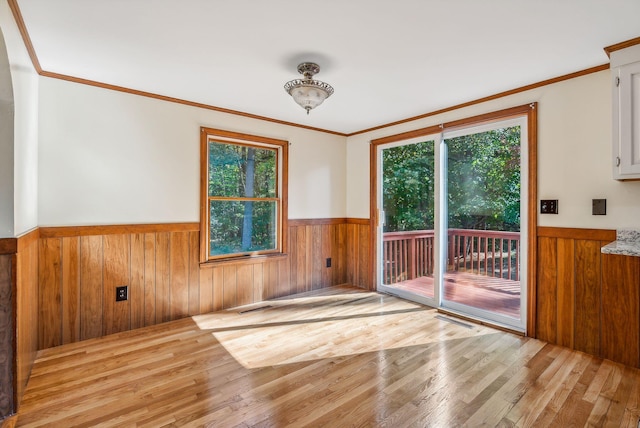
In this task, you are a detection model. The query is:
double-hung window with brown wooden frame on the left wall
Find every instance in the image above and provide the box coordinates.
[200,128,289,262]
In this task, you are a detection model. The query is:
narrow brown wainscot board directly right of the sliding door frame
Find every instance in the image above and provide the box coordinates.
[536,237,558,343]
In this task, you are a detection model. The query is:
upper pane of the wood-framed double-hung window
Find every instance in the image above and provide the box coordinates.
[209,141,277,198]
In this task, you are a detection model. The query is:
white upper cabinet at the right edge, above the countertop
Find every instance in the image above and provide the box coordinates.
[611,45,640,180]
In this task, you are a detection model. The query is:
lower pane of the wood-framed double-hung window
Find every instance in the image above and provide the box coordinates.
[209,201,277,256]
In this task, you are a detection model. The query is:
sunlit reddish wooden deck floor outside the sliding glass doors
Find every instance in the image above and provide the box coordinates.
[388,272,520,319]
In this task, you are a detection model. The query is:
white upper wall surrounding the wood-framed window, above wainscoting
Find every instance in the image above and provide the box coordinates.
[38,77,346,226]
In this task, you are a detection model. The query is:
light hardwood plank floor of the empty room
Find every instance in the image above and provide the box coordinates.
[8,287,640,427]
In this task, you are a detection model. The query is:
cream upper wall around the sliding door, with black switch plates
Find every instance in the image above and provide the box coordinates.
[347,70,640,229]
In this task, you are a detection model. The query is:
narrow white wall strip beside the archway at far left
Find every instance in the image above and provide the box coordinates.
[0,1,38,237]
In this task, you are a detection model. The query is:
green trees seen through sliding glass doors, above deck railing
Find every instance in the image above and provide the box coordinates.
[382,126,520,232]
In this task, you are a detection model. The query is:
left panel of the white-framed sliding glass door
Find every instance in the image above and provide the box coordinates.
[378,135,440,305]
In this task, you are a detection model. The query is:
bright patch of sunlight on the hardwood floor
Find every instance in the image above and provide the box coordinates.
[193,293,496,368]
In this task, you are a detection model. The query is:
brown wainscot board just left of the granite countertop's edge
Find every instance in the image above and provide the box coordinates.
[574,239,601,355]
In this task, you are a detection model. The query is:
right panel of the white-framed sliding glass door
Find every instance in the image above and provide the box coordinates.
[441,120,527,330]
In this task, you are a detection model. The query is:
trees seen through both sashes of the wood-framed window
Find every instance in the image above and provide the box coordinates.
[208,142,278,256]
